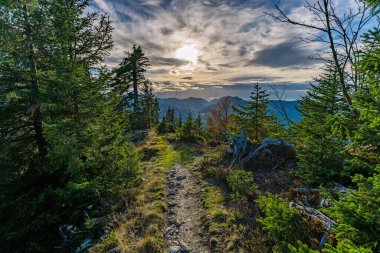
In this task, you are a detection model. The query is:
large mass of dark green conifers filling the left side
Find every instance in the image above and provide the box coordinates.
[0,0,138,252]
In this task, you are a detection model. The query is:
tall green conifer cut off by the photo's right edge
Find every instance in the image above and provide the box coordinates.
[343,29,380,176]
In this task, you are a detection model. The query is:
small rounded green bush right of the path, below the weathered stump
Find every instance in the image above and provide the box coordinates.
[227,169,257,198]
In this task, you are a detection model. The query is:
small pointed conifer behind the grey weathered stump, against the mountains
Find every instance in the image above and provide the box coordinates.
[233,83,273,142]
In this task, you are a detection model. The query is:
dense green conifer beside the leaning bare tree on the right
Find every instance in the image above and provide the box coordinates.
[295,68,348,185]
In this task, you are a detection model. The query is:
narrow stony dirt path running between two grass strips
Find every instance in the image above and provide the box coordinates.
[165,164,211,253]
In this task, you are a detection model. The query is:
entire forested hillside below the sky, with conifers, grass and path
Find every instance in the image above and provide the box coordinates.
[0,0,380,253]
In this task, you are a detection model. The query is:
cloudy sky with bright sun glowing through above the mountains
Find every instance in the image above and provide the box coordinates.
[92,0,347,100]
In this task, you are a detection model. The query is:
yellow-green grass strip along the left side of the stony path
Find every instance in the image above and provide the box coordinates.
[91,132,180,253]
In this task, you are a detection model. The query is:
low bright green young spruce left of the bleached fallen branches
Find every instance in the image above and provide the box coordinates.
[257,194,307,252]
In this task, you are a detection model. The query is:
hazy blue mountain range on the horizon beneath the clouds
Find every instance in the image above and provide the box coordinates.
[158,96,301,122]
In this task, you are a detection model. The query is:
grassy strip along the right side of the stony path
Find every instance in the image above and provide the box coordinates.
[187,146,270,253]
